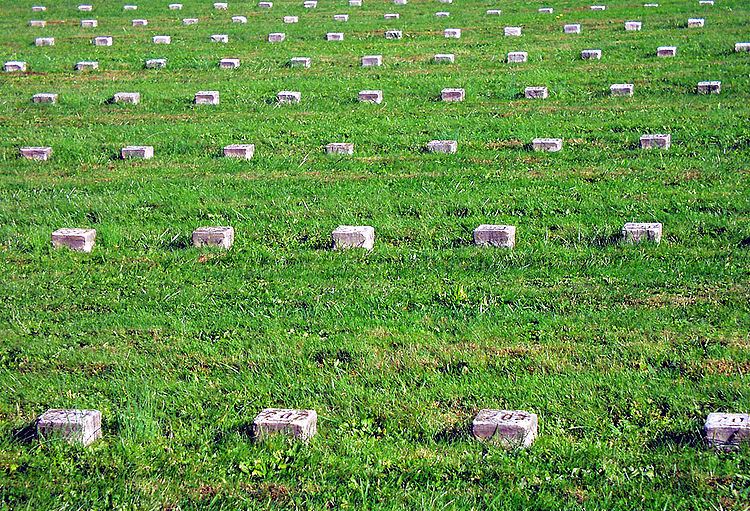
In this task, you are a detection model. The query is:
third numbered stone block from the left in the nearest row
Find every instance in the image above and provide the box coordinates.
[472,410,539,449]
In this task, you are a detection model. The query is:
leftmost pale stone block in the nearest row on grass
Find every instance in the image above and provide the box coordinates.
[36,410,102,447]
